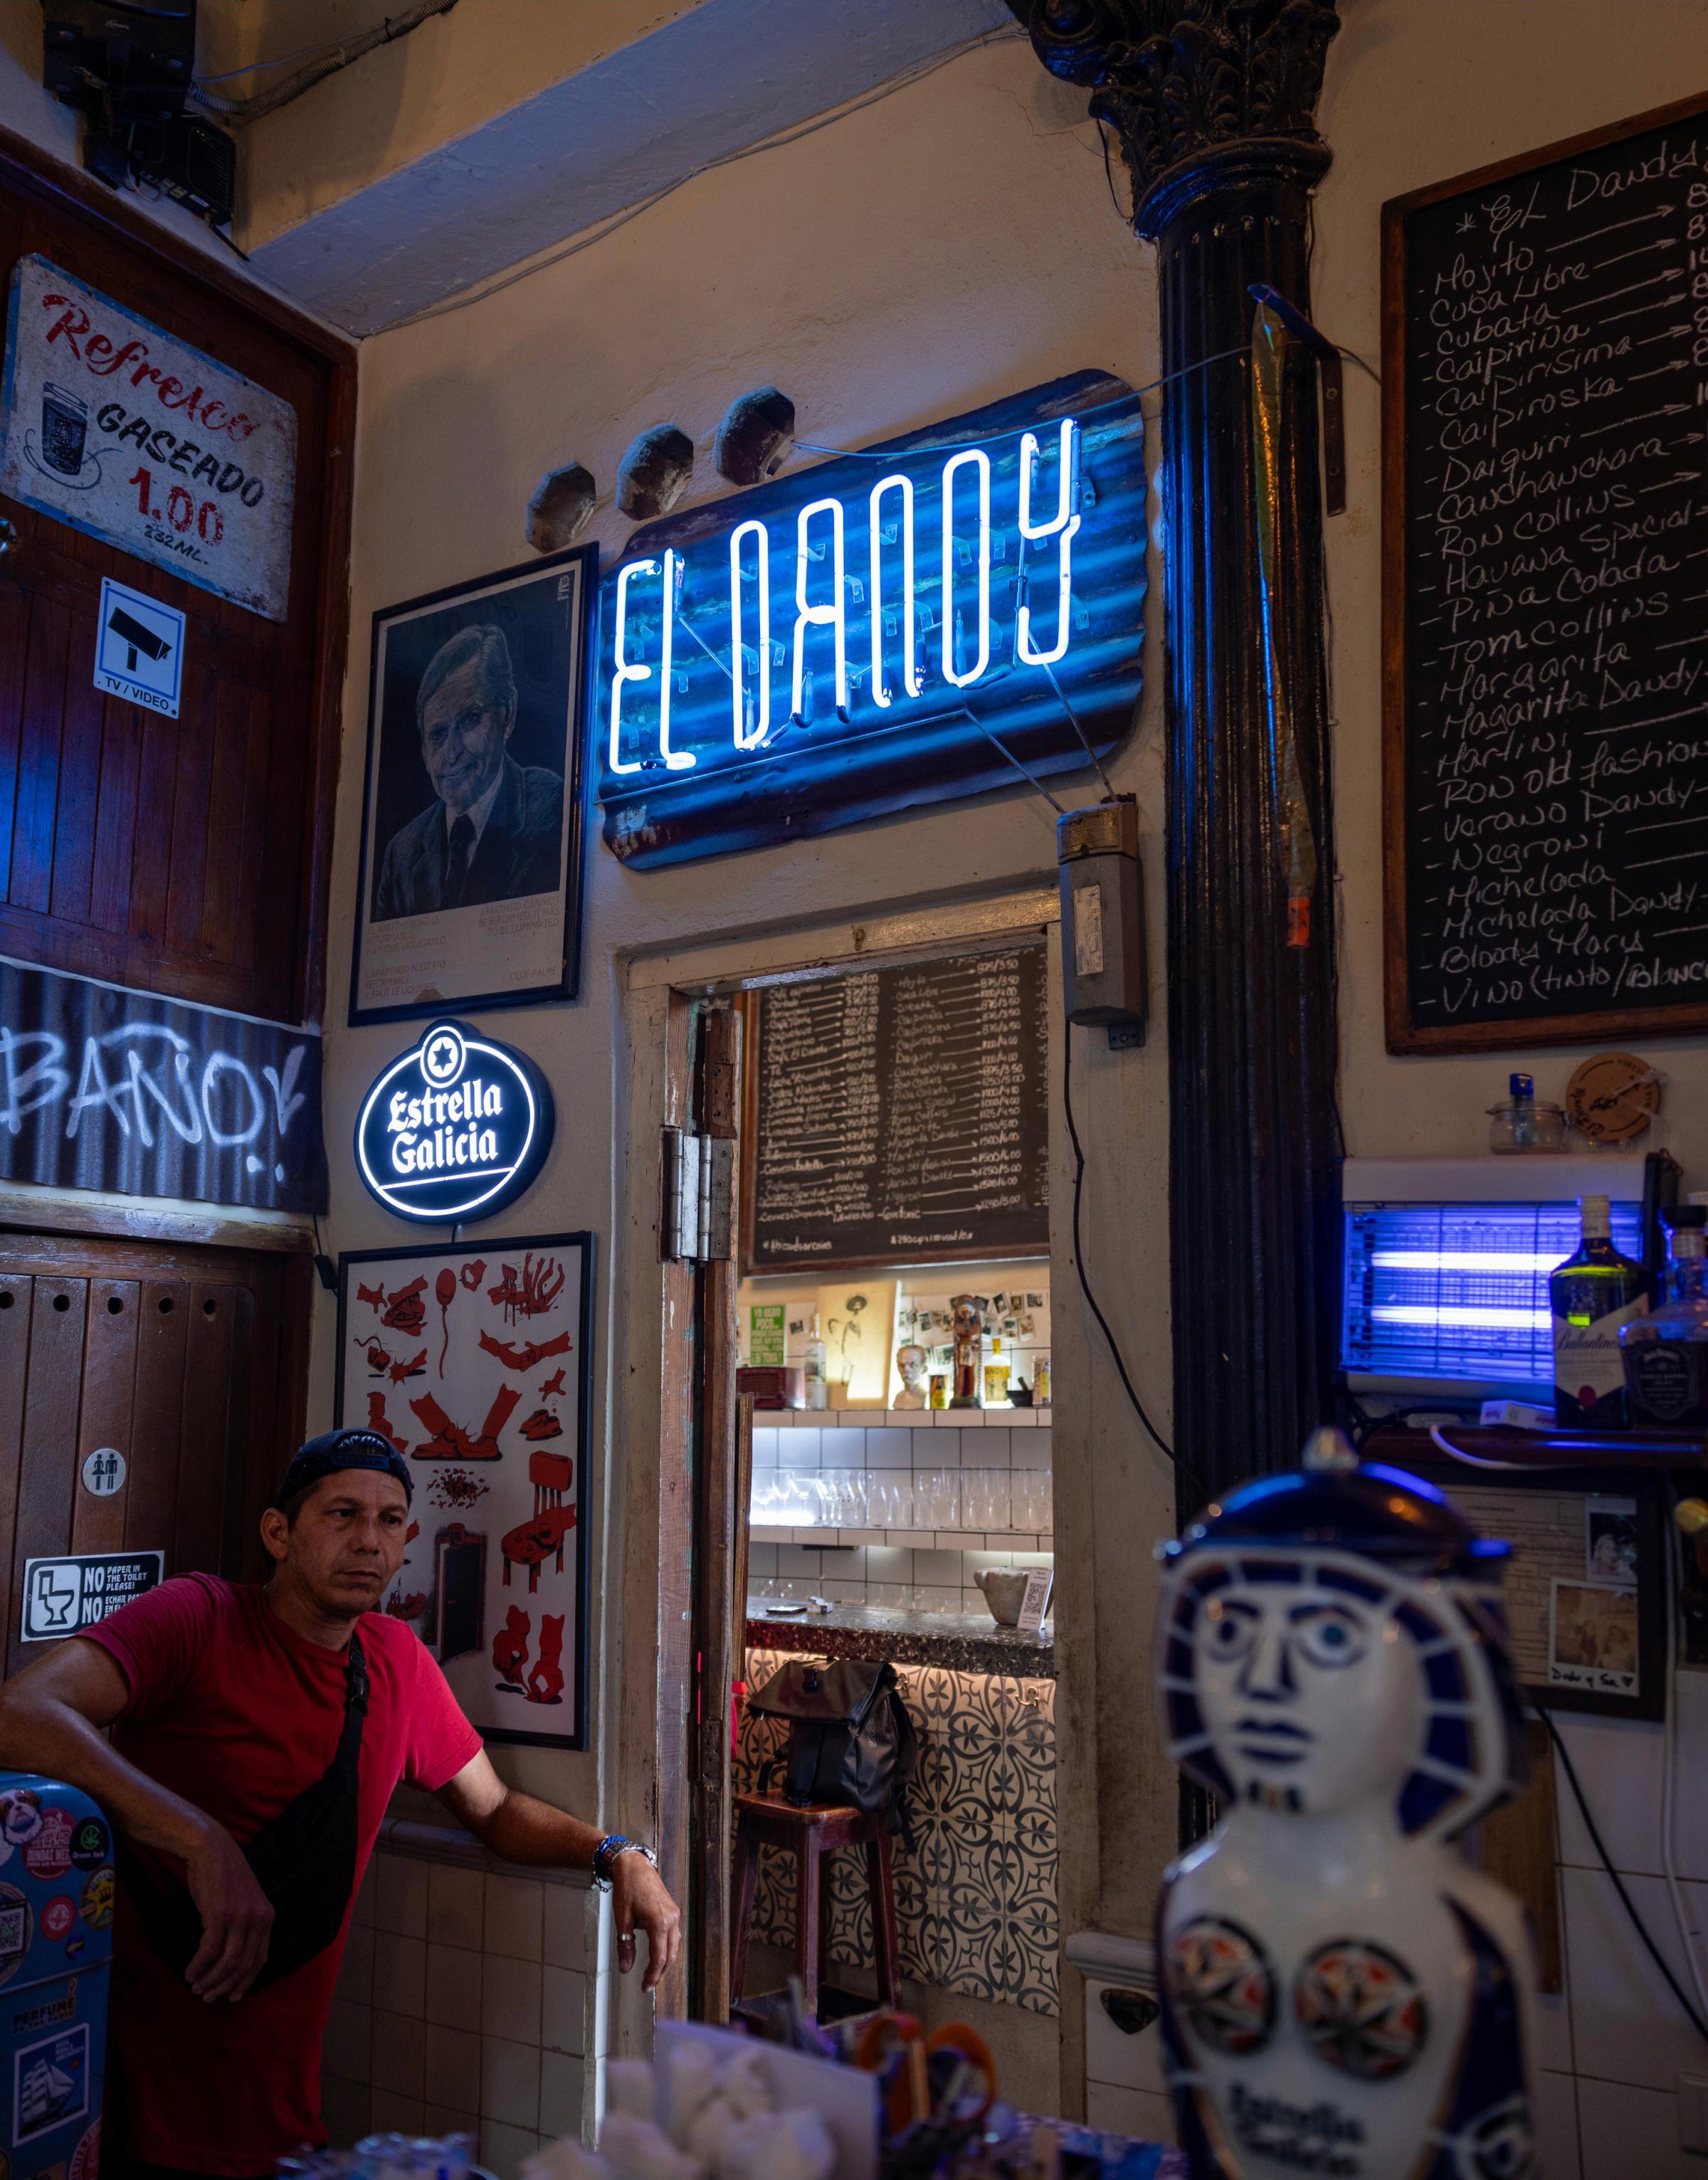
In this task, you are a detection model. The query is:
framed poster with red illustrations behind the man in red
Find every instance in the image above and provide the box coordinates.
[335,1234,593,1749]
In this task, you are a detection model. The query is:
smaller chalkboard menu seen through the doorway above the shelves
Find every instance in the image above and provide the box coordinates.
[743,939,1050,1271]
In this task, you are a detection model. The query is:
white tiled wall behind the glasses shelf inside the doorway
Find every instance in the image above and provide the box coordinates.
[747,1408,1055,1613]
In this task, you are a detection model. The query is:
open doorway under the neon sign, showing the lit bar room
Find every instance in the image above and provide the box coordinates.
[623,892,1059,2108]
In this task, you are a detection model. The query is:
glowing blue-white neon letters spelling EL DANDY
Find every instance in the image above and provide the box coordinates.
[608,418,1080,774]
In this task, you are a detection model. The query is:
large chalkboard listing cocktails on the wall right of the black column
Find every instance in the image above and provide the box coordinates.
[1383,98,1708,1050]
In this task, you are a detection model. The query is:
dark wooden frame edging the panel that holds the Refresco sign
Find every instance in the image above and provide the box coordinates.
[0,129,357,1023]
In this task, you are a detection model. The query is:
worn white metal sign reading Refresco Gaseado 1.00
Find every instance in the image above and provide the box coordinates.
[0,257,296,621]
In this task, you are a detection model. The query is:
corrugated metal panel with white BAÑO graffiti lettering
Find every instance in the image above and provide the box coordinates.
[0,959,327,1212]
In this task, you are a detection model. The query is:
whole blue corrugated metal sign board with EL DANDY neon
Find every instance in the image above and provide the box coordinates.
[595,371,1146,868]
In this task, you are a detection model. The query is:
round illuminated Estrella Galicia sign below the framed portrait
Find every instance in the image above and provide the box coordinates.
[355,1020,556,1225]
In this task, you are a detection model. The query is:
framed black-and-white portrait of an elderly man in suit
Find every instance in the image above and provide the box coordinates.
[351,545,599,1025]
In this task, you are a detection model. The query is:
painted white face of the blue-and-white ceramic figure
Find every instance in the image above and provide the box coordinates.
[1196,1581,1425,1816]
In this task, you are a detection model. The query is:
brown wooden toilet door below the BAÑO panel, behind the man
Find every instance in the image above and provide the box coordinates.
[0,1234,310,1672]
